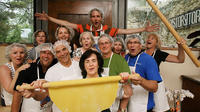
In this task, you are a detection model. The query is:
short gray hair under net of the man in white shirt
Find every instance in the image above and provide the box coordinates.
[53,40,71,53]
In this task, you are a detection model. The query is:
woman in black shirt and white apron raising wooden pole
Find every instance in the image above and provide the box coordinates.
[145,33,185,112]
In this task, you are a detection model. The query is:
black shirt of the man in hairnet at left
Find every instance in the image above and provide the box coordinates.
[14,58,58,90]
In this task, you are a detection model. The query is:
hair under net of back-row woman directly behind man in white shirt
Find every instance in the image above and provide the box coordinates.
[55,26,75,41]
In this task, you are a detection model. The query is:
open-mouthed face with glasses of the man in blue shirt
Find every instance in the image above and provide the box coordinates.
[127,38,142,56]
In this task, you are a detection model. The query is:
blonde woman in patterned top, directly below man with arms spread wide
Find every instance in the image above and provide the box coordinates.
[73,32,95,61]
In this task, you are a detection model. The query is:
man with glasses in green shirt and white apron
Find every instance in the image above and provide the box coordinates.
[98,34,132,112]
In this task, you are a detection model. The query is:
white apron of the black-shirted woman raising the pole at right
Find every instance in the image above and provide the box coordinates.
[152,50,169,112]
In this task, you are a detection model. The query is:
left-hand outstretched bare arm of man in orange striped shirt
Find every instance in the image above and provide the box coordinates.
[35,11,77,29]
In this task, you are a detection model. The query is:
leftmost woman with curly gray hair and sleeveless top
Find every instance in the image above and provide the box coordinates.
[0,43,27,106]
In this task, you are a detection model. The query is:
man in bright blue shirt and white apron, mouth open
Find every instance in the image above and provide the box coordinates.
[125,35,162,112]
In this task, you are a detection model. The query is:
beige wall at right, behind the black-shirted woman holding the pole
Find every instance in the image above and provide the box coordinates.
[160,50,200,89]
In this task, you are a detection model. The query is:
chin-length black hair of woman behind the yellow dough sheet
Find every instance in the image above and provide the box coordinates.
[79,49,103,78]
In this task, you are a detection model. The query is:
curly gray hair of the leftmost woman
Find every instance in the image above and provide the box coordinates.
[5,43,27,61]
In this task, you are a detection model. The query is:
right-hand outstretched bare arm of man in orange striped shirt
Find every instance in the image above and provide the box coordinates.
[118,22,159,34]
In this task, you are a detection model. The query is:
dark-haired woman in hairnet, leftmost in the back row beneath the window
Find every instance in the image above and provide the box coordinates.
[27,30,47,63]
